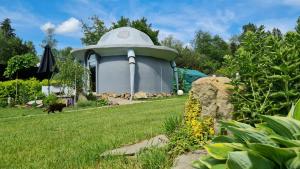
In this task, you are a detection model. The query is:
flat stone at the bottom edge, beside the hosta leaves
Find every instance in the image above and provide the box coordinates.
[171,150,207,169]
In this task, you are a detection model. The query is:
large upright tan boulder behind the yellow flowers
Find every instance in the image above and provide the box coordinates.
[191,77,233,120]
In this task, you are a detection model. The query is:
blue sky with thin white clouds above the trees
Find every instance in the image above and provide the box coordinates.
[0,0,300,54]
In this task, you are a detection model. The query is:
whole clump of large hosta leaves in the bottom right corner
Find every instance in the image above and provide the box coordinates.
[194,99,300,169]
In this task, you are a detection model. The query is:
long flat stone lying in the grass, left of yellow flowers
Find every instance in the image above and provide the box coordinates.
[100,135,169,157]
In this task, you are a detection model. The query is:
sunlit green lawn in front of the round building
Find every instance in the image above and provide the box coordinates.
[0,96,186,169]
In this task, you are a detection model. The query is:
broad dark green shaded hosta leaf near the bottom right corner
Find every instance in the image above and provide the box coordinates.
[248,143,297,167]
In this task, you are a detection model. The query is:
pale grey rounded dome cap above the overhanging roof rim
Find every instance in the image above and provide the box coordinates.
[97,27,154,46]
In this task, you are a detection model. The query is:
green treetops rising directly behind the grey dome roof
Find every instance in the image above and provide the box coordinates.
[81,16,159,45]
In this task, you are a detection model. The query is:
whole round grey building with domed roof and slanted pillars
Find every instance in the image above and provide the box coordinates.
[72,27,178,98]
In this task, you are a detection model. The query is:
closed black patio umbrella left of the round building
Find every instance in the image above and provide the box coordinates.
[37,45,57,94]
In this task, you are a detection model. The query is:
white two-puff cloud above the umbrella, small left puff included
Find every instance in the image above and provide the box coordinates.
[40,17,81,37]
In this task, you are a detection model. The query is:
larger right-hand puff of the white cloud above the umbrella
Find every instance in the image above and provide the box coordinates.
[55,17,81,34]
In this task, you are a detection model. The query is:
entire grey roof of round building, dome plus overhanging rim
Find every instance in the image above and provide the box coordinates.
[71,27,178,61]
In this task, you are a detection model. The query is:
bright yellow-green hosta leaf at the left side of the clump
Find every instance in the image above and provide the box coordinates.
[204,143,246,160]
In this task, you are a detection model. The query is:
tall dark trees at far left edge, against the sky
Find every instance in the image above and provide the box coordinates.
[0,19,36,65]
